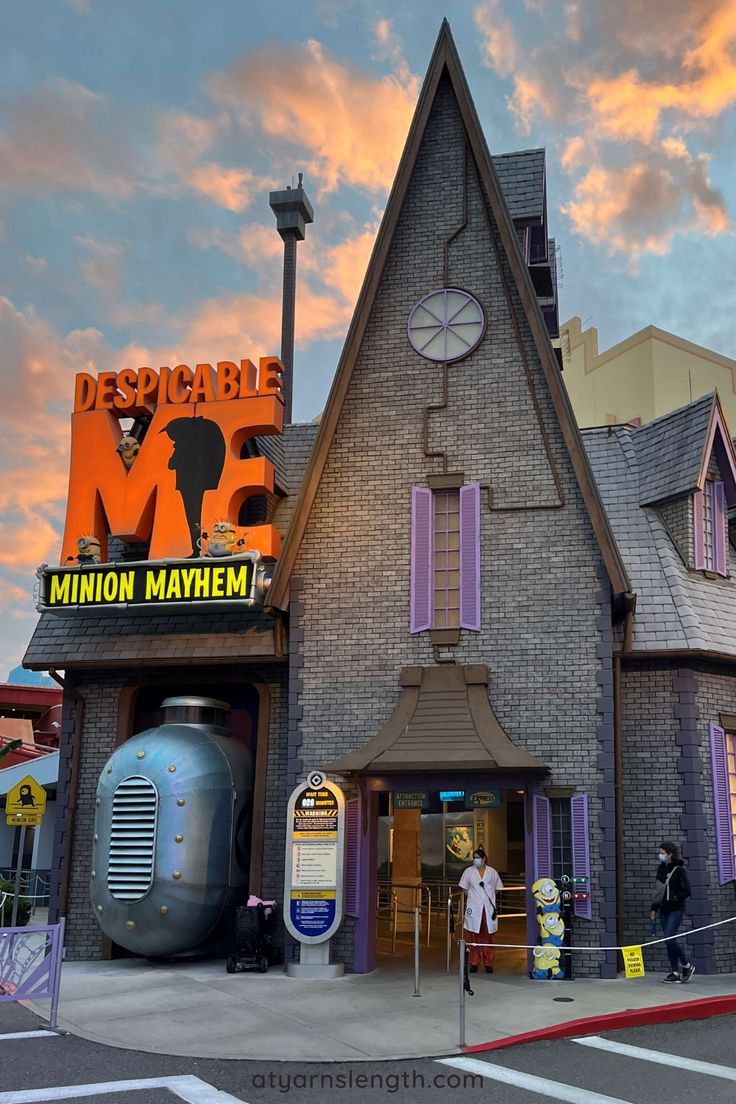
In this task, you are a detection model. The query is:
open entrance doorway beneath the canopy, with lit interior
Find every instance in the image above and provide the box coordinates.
[375,783,527,973]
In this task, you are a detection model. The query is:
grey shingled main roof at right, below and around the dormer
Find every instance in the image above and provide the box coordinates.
[583,415,736,656]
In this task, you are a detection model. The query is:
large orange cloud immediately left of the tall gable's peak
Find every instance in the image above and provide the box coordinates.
[209,40,416,192]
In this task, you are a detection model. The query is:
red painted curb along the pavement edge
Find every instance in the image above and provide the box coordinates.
[462,994,736,1054]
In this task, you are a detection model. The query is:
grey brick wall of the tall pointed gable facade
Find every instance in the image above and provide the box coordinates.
[290,75,614,972]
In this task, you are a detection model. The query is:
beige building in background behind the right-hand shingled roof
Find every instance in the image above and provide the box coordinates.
[559,317,736,434]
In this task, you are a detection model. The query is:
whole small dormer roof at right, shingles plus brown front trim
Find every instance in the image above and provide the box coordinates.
[631,392,736,506]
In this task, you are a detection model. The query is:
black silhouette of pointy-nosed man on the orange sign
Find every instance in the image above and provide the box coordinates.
[160,417,225,560]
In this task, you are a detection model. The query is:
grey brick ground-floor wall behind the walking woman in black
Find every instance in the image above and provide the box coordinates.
[621,660,736,973]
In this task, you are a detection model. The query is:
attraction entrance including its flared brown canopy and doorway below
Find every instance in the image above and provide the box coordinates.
[326,664,547,973]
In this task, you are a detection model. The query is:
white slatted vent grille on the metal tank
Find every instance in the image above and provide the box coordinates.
[107,775,159,901]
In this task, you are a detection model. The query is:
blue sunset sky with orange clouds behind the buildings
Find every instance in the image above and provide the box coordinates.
[0,0,736,679]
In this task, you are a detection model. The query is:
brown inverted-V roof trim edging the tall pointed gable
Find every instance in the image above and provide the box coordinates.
[269,20,630,609]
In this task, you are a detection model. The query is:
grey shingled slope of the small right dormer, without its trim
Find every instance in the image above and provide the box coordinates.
[632,393,716,506]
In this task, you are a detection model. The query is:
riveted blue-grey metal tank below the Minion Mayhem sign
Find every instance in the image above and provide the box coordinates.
[90,697,253,956]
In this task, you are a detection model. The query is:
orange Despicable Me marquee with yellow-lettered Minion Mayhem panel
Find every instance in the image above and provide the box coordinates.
[38,357,284,612]
